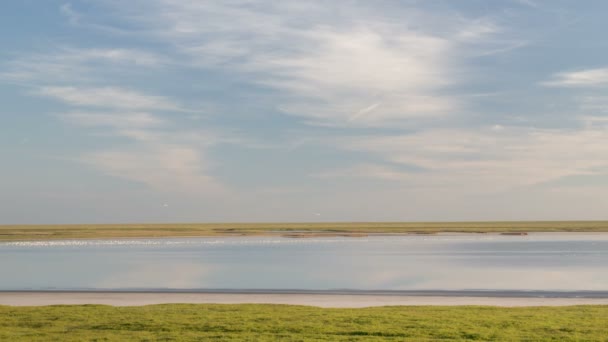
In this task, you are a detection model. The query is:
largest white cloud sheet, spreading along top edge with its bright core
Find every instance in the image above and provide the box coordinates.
[97,0,513,127]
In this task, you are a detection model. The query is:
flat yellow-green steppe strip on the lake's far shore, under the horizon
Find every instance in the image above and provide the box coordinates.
[0,221,608,242]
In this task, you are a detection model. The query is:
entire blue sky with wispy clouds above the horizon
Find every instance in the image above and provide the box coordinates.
[0,0,608,224]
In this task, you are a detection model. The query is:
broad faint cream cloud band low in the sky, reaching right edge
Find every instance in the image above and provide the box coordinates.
[325,127,608,192]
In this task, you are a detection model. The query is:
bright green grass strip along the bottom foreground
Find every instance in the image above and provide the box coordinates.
[0,304,608,341]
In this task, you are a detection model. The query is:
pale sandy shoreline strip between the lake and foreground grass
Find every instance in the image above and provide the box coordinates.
[0,292,608,308]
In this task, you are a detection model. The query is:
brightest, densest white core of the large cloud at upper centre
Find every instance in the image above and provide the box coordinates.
[257,29,458,126]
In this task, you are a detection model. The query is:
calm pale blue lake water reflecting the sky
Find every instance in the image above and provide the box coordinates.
[0,233,608,291]
